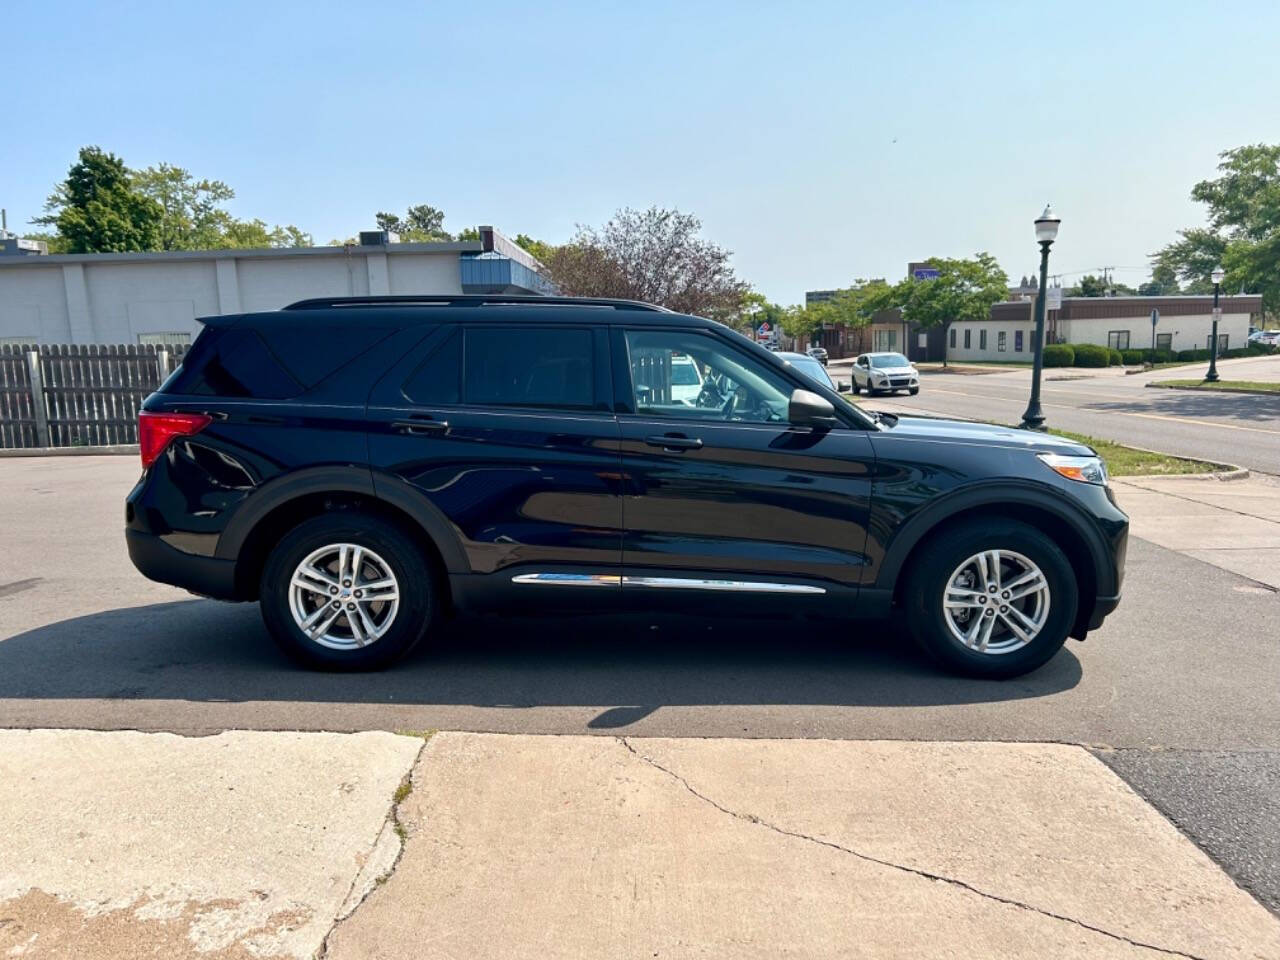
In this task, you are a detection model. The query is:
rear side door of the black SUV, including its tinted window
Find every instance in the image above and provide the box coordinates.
[369,320,622,596]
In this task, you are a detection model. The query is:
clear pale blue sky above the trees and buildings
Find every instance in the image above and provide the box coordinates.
[10,0,1280,303]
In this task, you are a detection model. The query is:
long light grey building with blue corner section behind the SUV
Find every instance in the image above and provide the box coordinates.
[0,227,552,344]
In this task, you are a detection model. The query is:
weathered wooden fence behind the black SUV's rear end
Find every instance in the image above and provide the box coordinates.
[0,344,187,447]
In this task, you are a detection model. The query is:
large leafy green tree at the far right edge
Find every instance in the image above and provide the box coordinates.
[1155,143,1280,315]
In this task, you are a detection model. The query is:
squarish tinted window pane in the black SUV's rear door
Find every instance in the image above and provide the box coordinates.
[462,326,595,408]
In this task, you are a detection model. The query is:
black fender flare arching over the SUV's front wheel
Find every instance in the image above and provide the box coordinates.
[876,480,1116,593]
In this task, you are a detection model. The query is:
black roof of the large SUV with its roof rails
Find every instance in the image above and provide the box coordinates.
[201,294,710,326]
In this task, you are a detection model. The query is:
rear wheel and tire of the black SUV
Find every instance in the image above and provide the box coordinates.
[259,512,442,671]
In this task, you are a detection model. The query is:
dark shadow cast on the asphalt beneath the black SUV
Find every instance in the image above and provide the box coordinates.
[0,599,1080,728]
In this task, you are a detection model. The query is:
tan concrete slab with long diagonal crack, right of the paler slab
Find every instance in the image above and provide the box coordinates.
[326,733,1280,960]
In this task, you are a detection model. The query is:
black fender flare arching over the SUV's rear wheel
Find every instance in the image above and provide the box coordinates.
[214,465,471,573]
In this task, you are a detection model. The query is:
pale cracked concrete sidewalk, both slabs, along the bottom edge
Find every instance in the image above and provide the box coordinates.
[0,731,1280,960]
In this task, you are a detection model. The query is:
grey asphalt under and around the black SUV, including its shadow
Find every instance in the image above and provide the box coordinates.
[0,455,1280,910]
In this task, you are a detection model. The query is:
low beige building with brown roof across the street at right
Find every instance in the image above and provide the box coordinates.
[946,296,1262,361]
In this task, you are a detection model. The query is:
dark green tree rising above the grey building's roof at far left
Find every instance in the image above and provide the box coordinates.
[32,147,164,253]
